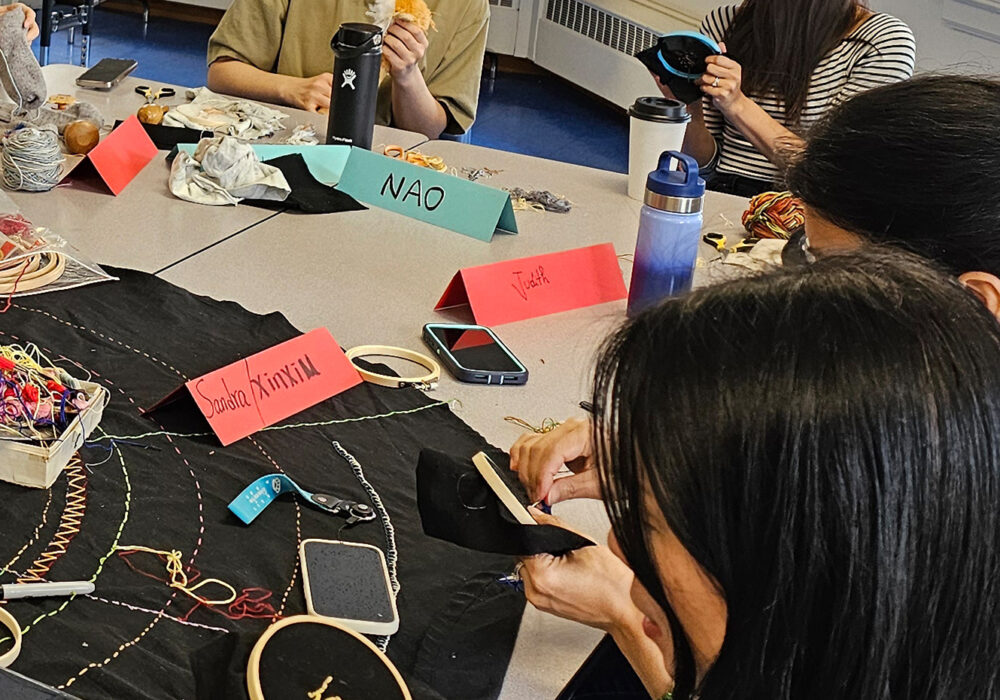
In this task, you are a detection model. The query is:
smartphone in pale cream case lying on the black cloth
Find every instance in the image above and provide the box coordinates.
[299,539,399,635]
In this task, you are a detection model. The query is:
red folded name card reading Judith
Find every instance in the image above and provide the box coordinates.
[434,243,627,326]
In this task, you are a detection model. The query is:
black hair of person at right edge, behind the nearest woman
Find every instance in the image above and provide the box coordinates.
[787,75,1000,275]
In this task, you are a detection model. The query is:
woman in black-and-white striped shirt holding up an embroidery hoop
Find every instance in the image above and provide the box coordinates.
[660,0,916,196]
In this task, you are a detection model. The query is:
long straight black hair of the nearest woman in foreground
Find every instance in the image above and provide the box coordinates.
[594,251,1000,700]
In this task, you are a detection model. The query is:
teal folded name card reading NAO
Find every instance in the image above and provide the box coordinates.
[337,147,517,242]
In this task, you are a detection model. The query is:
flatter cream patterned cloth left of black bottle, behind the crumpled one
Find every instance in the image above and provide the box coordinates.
[163,87,288,141]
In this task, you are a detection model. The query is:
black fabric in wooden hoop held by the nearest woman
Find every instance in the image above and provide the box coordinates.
[417,449,594,556]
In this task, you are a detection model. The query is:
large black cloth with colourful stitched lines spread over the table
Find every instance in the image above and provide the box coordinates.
[0,268,524,700]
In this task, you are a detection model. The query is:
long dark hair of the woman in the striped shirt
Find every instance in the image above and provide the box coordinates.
[725,0,864,124]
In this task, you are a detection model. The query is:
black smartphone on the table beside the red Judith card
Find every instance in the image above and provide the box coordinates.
[424,323,528,384]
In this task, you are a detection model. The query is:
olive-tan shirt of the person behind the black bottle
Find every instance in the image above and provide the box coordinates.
[208,0,489,134]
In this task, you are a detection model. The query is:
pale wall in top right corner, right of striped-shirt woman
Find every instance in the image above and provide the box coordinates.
[870,0,1000,74]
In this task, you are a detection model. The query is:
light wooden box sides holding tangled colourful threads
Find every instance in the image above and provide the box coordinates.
[0,381,109,489]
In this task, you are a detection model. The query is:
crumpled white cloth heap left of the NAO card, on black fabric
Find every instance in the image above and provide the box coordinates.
[169,136,292,206]
